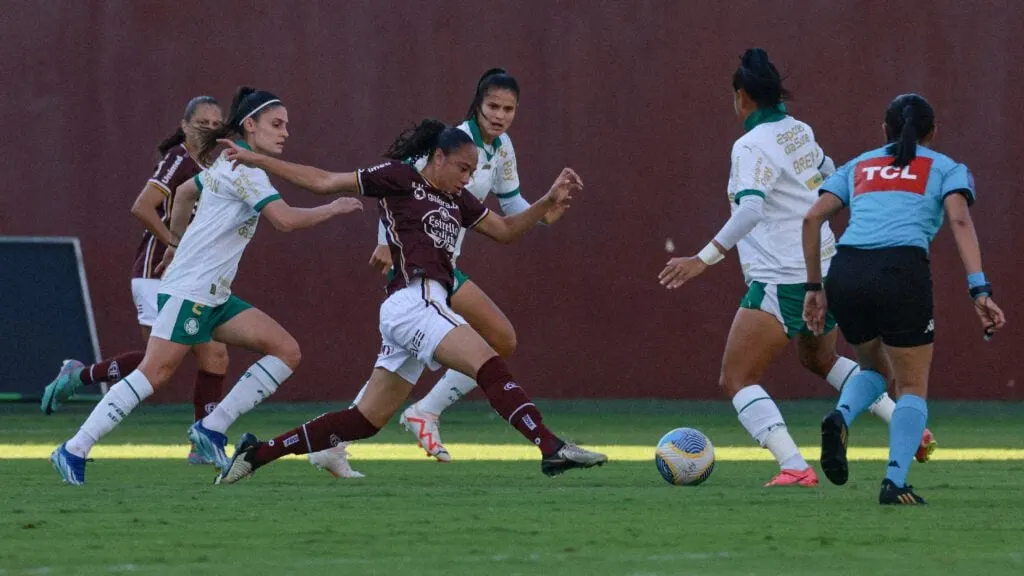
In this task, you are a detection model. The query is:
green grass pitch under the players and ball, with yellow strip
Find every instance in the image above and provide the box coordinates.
[0,401,1024,576]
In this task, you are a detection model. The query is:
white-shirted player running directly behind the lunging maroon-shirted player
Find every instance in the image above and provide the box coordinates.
[309,68,564,478]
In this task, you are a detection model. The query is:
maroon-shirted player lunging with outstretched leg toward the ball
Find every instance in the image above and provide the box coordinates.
[210,120,607,484]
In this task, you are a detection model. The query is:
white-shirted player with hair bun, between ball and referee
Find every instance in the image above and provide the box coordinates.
[658,48,934,487]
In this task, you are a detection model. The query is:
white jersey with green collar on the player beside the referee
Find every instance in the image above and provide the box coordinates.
[728,107,836,284]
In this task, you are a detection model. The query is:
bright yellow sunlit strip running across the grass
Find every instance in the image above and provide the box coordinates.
[0,442,1024,462]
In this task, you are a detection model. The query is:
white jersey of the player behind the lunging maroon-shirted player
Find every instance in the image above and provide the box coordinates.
[377,120,529,263]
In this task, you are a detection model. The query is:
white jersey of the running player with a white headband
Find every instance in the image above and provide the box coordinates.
[160,141,281,306]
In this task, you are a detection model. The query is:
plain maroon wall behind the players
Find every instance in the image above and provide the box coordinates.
[0,0,1024,401]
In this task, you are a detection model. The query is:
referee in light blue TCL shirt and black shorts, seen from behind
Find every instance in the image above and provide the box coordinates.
[804,94,1006,504]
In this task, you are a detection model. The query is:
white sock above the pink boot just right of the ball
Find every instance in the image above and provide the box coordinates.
[732,384,807,470]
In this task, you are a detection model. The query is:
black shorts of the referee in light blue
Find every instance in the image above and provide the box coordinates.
[825,246,935,347]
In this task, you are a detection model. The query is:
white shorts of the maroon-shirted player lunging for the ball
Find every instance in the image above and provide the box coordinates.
[374,279,466,384]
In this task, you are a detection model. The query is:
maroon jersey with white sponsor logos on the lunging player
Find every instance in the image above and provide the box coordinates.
[356,161,489,294]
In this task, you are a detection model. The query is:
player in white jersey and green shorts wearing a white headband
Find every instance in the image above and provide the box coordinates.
[50,87,362,485]
